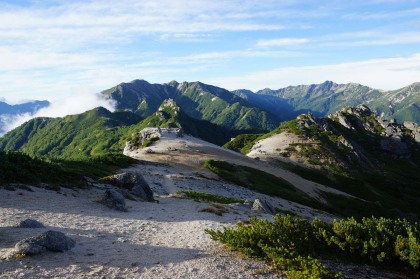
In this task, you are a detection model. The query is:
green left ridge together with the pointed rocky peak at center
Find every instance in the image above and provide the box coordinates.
[0,100,232,160]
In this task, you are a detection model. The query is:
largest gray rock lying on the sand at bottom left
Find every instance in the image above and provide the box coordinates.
[15,231,76,255]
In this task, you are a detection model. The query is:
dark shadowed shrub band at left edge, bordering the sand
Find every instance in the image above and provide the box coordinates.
[0,151,136,187]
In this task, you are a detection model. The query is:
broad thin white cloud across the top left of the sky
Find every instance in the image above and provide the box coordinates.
[0,0,283,49]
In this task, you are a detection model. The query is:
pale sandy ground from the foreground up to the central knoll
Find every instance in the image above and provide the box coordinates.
[0,133,403,278]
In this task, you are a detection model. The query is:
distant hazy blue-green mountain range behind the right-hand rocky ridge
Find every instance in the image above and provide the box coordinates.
[233,81,420,123]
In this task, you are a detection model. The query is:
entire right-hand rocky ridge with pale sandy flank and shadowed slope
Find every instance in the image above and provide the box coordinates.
[229,105,420,220]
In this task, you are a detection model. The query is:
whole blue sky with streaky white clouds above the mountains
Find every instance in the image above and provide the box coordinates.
[0,0,420,102]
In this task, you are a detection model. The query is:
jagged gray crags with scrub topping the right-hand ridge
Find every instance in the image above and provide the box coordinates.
[256,105,420,169]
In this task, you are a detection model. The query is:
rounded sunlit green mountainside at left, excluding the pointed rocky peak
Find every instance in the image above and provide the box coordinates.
[0,107,141,159]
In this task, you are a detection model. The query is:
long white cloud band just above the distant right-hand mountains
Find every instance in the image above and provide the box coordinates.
[207,53,420,90]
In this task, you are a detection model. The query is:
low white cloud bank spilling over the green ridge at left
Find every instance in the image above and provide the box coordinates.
[0,90,114,133]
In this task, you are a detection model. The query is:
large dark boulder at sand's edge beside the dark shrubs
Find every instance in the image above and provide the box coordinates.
[105,172,155,202]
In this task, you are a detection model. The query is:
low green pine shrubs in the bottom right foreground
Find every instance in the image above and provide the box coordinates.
[206,215,420,279]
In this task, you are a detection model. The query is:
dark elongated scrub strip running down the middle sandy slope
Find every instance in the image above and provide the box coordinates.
[204,160,324,211]
